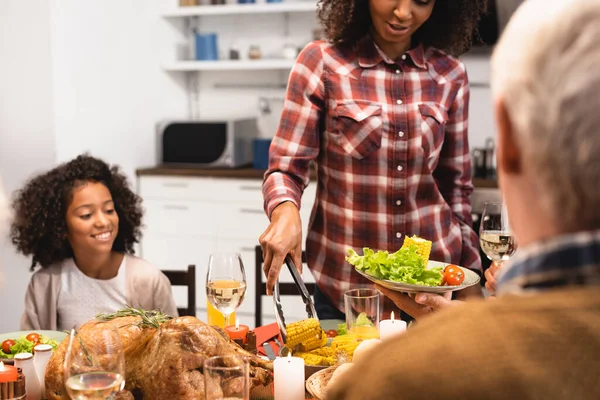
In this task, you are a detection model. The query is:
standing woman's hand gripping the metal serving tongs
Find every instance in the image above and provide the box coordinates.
[257,201,302,295]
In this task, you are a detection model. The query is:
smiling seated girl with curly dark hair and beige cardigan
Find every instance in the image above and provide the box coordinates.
[11,155,177,330]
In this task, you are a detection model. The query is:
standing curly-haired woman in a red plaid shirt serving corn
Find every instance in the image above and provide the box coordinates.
[260,0,486,318]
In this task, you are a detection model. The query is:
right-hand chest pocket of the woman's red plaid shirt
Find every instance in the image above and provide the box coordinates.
[417,103,448,167]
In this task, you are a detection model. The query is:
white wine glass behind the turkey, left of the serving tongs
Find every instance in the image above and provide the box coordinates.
[206,253,246,326]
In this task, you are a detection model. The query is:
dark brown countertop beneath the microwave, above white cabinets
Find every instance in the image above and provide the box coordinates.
[136,165,498,188]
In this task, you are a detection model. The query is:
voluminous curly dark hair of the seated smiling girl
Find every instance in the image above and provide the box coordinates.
[10,154,143,271]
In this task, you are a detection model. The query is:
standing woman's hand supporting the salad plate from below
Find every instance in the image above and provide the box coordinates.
[375,285,462,320]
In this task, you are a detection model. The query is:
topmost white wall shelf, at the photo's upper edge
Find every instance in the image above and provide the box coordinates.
[163,1,317,18]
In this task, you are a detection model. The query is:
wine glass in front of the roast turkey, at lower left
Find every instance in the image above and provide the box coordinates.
[63,322,125,400]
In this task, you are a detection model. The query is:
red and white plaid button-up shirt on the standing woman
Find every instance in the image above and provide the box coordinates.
[263,36,481,310]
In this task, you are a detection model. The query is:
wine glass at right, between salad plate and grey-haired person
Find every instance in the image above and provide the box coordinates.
[479,203,517,267]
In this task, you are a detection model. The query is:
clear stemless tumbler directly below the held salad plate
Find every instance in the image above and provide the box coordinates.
[344,289,381,338]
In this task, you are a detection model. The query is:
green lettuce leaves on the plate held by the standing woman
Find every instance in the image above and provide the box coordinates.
[346,246,443,286]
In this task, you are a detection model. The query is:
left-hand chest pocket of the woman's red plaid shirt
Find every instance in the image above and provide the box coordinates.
[330,101,383,159]
